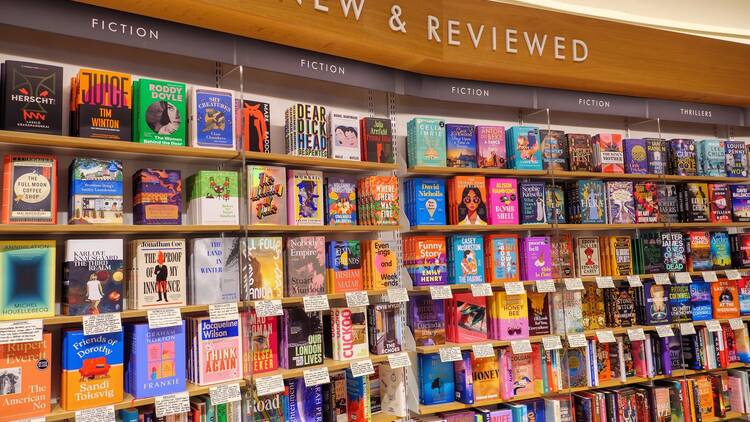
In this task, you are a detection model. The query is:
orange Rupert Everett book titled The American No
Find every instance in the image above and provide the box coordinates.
[0,333,52,422]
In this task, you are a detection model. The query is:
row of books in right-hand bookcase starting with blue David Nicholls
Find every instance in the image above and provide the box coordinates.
[412,176,750,226]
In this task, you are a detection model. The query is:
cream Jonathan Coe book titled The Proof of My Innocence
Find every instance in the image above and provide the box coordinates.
[128,239,187,309]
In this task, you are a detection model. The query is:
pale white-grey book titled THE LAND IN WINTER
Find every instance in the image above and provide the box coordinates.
[190,237,240,305]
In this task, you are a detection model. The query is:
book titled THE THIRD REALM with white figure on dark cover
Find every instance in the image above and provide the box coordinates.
[61,239,125,315]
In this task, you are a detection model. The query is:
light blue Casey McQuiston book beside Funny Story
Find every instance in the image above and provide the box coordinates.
[448,234,484,284]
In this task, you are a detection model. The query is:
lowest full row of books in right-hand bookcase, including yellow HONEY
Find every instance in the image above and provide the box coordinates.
[418,324,750,405]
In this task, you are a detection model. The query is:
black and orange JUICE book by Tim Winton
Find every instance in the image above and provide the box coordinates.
[70,69,133,141]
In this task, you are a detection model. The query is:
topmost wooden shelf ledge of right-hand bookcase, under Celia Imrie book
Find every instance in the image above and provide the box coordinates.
[407,166,750,184]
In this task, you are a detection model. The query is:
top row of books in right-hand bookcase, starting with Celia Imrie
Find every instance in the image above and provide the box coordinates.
[407,117,747,177]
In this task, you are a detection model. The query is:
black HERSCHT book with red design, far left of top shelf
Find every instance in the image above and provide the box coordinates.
[0,60,65,135]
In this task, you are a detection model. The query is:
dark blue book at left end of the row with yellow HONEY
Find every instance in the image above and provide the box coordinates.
[418,353,455,405]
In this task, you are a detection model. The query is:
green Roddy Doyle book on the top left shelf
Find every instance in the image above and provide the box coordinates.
[133,78,188,146]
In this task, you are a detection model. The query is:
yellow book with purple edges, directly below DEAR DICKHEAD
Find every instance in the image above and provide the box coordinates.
[287,170,324,226]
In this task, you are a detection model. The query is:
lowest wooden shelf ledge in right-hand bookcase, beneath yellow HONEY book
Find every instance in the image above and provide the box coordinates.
[418,363,748,419]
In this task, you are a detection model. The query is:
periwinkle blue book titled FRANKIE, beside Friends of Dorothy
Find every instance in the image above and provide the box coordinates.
[125,322,185,399]
